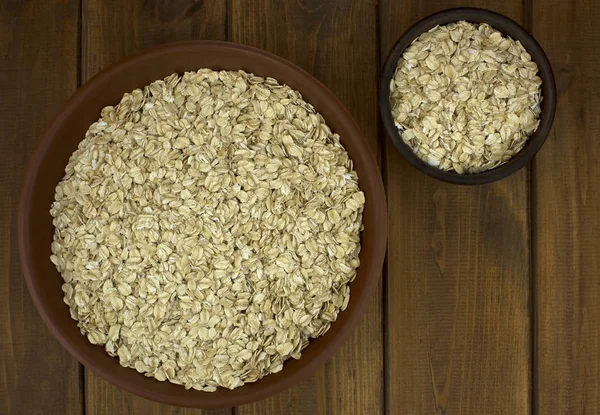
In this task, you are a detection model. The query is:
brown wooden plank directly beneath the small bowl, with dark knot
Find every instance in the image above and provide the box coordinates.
[380,0,531,414]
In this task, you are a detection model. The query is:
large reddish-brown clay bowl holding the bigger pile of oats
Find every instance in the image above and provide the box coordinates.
[19,41,387,407]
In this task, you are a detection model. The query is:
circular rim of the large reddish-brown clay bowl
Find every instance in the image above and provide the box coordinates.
[17,40,387,408]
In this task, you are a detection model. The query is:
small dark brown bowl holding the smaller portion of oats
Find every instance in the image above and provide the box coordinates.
[379,7,556,184]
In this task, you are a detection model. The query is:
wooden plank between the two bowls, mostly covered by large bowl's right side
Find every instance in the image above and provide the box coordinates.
[230,0,383,415]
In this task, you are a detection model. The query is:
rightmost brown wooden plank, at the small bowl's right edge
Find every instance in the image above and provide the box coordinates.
[533,0,600,414]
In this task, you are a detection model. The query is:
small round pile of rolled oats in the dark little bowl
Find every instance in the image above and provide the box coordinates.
[389,21,542,174]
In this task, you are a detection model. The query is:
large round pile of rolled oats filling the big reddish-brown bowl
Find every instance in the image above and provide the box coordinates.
[51,69,365,391]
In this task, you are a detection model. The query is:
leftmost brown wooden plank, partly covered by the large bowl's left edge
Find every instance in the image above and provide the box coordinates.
[0,0,83,414]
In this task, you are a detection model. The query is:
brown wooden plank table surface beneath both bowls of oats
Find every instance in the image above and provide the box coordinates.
[0,0,600,415]
